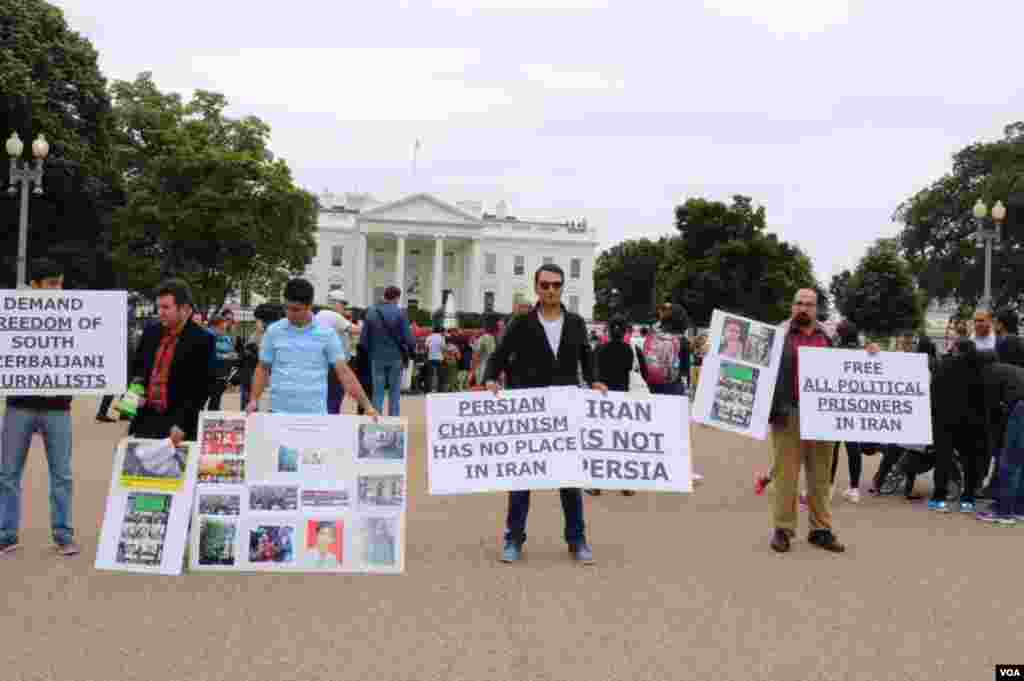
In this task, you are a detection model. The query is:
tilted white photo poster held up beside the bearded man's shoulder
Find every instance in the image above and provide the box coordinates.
[693,310,785,439]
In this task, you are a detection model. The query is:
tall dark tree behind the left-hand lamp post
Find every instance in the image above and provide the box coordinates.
[0,0,121,288]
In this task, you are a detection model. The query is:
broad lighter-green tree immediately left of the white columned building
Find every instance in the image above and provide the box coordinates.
[112,73,317,308]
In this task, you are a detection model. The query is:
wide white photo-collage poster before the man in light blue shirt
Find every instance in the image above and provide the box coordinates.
[190,414,408,573]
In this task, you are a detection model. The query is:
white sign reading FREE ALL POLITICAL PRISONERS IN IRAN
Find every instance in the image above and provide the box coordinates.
[798,347,932,444]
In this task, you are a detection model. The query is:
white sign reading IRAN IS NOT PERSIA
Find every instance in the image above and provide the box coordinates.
[577,390,692,492]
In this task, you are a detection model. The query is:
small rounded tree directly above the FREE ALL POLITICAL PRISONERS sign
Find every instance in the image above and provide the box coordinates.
[830,239,925,336]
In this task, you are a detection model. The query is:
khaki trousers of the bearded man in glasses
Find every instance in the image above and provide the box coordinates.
[771,414,833,533]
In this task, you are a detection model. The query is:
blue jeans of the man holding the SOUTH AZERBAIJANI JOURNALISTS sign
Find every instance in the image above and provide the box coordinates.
[0,407,75,544]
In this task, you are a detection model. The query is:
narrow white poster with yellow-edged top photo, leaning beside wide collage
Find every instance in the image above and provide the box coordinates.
[95,438,199,574]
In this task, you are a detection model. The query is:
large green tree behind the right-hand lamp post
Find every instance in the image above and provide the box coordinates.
[894,122,1024,306]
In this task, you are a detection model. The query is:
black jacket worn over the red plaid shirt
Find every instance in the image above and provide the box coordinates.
[129,320,214,440]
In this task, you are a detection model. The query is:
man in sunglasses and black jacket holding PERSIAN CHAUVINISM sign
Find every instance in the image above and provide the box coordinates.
[484,264,608,563]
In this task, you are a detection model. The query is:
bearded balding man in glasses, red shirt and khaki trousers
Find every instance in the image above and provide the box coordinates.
[769,289,879,553]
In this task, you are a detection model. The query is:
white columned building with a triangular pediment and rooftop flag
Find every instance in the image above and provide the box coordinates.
[305,193,598,320]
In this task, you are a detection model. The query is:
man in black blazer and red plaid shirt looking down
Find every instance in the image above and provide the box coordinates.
[128,280,214,440]
